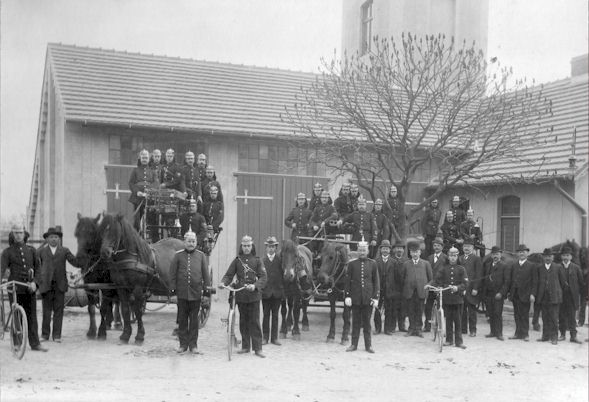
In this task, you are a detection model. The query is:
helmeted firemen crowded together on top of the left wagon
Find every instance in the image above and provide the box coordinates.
[129,149,224,248]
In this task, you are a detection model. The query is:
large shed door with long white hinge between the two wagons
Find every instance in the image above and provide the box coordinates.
[235,173,328,245]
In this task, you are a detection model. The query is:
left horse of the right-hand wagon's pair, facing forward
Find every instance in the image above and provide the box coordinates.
[280,239,313,339]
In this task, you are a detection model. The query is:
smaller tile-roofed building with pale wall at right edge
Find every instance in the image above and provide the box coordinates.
[440,54,589,252]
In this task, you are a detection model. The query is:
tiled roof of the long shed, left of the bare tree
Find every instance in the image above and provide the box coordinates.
[47,44,315,135]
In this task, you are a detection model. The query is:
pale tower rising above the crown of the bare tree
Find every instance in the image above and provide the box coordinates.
[342,0,489,54]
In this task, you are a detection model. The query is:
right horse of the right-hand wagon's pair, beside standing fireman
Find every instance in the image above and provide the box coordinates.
[317,241,351,345]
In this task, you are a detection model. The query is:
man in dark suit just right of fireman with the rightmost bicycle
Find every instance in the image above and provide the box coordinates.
[460,239,484,337]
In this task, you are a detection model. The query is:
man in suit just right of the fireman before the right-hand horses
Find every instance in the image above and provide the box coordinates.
[374,240,395,335]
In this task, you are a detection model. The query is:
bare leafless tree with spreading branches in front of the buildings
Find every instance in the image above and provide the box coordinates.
[282,34,551,238]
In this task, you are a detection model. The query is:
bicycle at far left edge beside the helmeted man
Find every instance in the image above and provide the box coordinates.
[0,281,29,360]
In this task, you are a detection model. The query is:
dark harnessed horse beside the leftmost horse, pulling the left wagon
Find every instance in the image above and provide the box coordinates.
[98,214,184,344]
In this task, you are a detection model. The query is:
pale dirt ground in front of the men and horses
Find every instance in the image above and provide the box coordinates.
[0,294,588,401]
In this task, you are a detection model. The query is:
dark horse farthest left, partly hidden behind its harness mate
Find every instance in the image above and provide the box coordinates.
[74,214,118,340]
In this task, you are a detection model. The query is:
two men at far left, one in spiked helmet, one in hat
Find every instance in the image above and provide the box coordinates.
[0,225,80,352]
